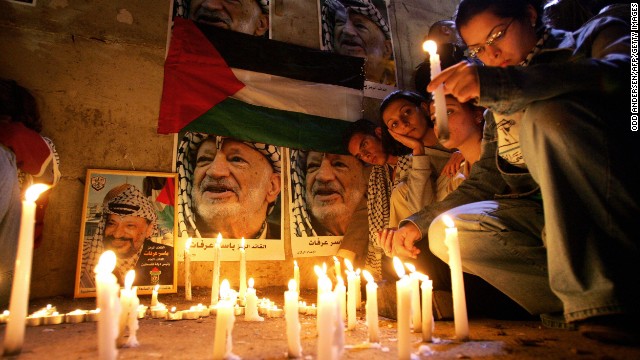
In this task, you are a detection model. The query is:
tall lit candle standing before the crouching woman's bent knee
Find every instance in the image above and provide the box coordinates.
[442,215,469,340]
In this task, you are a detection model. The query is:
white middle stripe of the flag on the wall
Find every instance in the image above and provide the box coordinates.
[231,68,363,121]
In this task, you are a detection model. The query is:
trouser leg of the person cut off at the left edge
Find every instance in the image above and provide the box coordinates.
[0,145,22,309]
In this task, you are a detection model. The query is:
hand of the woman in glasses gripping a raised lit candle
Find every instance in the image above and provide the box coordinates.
[427,61,480,103]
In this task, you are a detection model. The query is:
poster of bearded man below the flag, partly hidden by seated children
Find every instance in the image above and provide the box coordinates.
[288,149,368,257]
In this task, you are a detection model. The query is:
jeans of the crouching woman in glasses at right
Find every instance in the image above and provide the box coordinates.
[429,98,640,322]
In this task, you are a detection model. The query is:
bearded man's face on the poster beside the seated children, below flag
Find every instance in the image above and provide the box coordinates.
[305,151,366,235]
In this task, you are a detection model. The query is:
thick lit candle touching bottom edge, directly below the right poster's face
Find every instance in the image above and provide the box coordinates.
[317,278,339,360]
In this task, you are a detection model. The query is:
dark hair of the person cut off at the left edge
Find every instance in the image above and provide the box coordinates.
[0,79,42,132]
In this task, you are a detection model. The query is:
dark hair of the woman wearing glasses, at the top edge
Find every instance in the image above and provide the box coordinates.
[454,0,544,32]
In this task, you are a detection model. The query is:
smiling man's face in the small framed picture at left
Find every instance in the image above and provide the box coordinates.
[104,214,153,259]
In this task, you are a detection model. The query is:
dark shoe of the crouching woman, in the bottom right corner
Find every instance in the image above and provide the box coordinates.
[577,314,640,346]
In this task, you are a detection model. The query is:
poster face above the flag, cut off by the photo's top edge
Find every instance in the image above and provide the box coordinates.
[189,0,269,36]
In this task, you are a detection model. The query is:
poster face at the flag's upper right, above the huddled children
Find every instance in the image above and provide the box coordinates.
[334,8,392,67]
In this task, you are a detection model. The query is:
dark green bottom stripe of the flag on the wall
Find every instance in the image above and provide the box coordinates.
[183,98,350,154]
